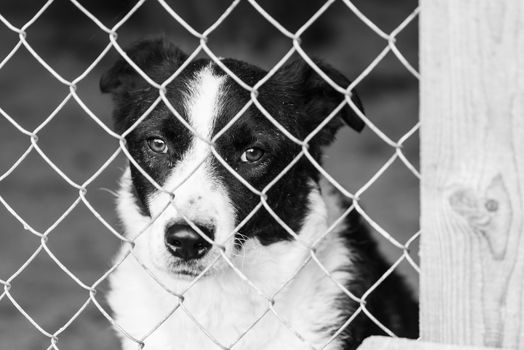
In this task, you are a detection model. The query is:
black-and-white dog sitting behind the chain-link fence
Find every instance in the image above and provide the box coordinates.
[100,38,418,350]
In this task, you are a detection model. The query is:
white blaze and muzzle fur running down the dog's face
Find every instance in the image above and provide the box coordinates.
[141,67,235,273]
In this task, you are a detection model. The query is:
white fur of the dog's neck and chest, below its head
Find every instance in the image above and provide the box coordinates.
[108,173,351,350]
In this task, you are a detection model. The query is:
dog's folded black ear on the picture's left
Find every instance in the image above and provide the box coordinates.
[100,38,187,98]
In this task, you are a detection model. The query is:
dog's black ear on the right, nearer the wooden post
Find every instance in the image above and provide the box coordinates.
[275,59,365,144]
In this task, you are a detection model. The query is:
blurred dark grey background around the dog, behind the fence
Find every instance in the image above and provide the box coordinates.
[0,0,419,350]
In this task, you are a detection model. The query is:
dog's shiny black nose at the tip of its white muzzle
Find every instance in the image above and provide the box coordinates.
[165,224,214,260]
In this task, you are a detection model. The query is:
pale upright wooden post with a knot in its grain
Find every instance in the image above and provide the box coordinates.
[420,0,524,349]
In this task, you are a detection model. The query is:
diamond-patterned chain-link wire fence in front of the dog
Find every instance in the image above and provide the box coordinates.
[0,0,420,349]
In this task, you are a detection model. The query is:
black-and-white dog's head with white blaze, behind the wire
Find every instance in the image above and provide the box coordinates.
[100,39,364,275]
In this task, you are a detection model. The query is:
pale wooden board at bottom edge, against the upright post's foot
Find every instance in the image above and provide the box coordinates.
[358,337,508,350]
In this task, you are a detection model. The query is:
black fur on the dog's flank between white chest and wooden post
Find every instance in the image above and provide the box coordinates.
[330,208,419,350]
